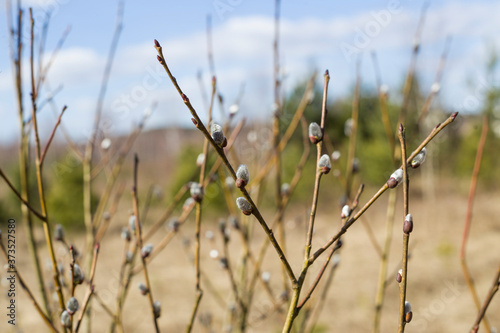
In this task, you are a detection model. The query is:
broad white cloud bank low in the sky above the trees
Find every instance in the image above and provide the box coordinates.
[0,2,500,143]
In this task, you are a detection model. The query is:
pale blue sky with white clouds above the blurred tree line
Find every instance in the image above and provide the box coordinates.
[0,0,500,143]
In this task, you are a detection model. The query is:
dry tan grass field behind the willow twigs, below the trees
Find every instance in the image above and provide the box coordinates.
[0,175,500,333]
